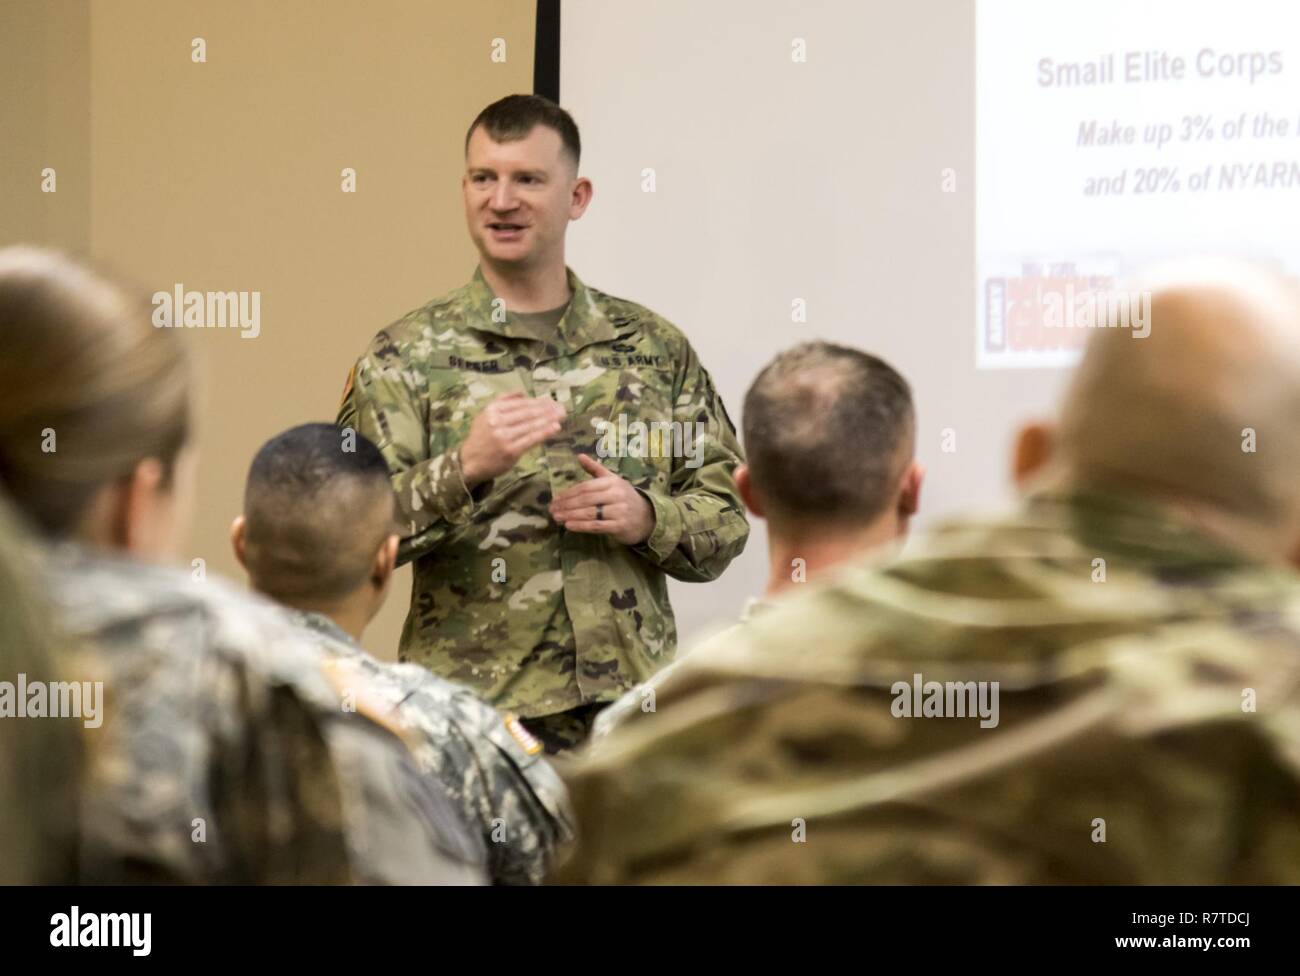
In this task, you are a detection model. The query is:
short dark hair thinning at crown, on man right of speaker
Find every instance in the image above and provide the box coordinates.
[742,342,915,524]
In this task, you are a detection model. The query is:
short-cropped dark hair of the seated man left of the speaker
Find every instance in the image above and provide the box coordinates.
[244,424,397,603]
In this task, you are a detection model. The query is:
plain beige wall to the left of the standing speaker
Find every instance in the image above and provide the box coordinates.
[0,0,536,656]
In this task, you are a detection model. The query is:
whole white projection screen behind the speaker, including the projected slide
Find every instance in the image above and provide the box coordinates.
[560,0,1300,645]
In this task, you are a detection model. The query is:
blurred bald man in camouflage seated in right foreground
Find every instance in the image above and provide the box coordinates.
[562,261,1300,884]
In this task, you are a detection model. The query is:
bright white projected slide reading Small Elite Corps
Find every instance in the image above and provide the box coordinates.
[975,0,1300,366]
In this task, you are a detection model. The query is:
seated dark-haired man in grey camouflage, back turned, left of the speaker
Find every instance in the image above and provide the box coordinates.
[231,424,572,884]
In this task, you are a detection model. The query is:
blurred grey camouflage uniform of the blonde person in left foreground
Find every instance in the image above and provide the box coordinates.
[48,545,485,884]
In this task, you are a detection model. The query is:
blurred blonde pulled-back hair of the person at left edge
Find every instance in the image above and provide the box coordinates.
[0,247,190,537]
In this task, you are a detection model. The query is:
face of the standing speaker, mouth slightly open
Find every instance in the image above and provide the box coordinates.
[462,125,590,268]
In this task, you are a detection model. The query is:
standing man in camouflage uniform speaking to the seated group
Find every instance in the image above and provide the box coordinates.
[338,95,749,751]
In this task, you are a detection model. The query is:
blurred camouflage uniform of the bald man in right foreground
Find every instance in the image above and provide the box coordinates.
[562,493,1300,884]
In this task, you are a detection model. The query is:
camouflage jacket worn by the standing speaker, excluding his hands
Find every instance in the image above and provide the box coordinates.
[338,272,749,730]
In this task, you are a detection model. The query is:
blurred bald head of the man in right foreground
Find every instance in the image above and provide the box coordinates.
[1058,259,1300,561]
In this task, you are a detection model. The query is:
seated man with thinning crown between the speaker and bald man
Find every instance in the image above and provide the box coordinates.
[592,342,924,739]
